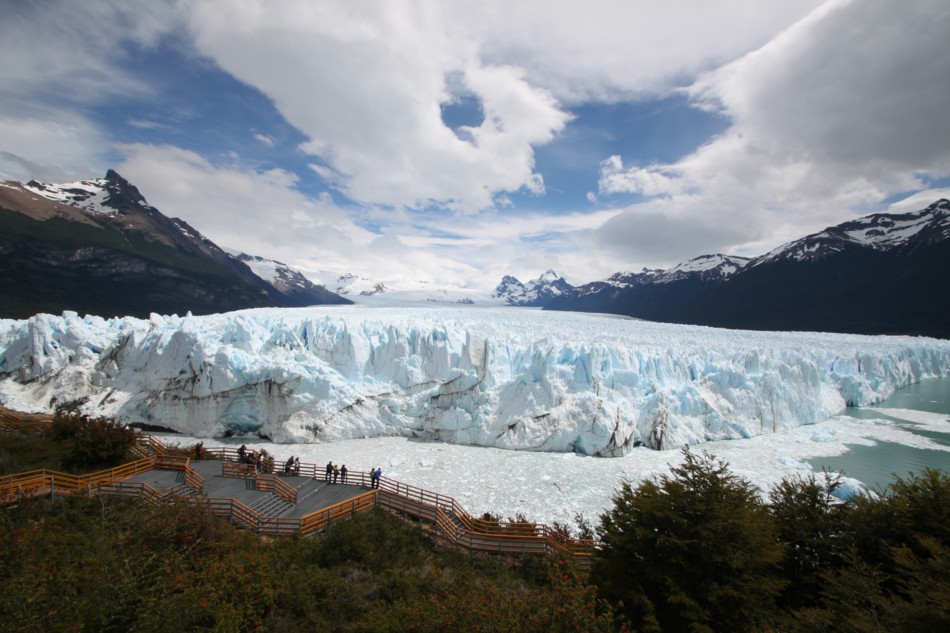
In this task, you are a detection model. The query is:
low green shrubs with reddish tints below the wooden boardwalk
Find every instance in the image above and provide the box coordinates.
[0,498,615,632]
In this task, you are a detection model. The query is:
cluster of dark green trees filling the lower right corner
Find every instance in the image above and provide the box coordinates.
[591,450,950,633]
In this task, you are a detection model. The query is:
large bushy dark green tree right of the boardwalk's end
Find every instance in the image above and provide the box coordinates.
[591,448,783,631]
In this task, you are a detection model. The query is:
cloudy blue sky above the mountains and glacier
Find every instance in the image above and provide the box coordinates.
[0,0,950,290]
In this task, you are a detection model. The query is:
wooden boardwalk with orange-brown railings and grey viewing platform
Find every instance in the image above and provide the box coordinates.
[0,408,597,568]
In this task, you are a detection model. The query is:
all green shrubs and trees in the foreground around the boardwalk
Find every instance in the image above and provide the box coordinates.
[0,422,950,633]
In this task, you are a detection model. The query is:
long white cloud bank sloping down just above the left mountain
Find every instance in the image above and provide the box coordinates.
[117,144,516,282]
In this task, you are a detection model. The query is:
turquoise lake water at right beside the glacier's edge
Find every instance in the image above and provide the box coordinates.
[808,378,950,489]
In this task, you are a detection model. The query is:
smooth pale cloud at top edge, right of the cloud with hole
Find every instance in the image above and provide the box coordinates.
[456,0,821,104]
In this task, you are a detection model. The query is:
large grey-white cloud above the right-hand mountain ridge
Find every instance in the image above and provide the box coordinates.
[598,0,950,261]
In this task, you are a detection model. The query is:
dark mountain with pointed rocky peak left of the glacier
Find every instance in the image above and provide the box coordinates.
[0,170,350,318]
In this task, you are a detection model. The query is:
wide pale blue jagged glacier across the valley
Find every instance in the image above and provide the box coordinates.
[0,306,950,457]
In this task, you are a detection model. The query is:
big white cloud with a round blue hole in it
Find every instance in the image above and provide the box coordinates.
[190,0,569,211]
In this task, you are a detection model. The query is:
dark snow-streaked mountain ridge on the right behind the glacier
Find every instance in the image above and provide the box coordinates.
[546,199,950,338]
